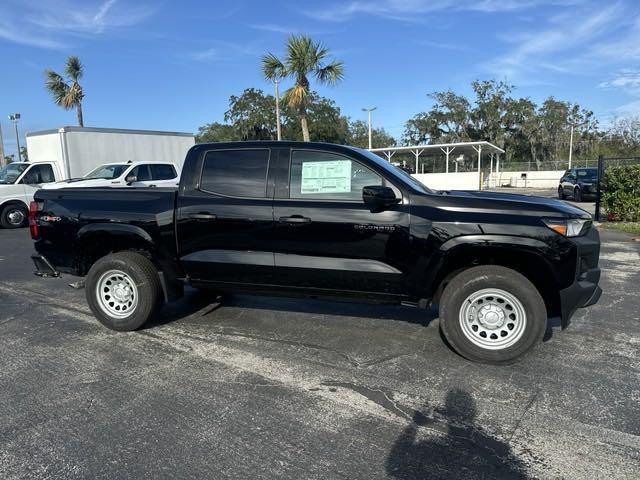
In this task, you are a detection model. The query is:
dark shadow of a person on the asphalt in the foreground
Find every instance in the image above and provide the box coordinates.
[385,388,529,480]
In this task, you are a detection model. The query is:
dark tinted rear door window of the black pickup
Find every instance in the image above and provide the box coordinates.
[200,149,269,198]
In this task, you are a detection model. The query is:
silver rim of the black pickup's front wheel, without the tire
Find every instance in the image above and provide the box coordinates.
[459,288,527,350]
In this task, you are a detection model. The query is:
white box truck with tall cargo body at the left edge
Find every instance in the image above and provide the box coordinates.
[0,127,195,228]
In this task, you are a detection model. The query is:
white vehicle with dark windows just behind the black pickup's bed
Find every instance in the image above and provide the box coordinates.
[42,162,179,190]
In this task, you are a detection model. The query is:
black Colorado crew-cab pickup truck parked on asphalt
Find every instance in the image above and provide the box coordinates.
[29,142,601,363]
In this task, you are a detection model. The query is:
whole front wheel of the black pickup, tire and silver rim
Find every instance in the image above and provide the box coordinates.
[440,265,547,364]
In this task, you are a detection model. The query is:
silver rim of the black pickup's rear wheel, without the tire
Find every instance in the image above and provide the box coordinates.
[96,270,138,318]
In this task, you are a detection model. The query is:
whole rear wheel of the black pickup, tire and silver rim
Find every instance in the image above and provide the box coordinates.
[85,252,162,332]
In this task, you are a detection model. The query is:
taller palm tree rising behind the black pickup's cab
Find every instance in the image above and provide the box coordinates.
[262,35,344,142]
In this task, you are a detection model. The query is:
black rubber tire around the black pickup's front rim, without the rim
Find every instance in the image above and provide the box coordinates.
[439,265,547,365]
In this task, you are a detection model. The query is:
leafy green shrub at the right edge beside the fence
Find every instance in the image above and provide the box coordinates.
[602,164,640,222]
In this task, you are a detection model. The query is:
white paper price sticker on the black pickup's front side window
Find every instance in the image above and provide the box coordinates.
[300,160,351,194]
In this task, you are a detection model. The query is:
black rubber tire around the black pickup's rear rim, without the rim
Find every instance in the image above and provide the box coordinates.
[85,252,163,332]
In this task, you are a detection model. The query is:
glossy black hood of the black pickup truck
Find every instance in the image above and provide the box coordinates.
[418,190,591,218]
